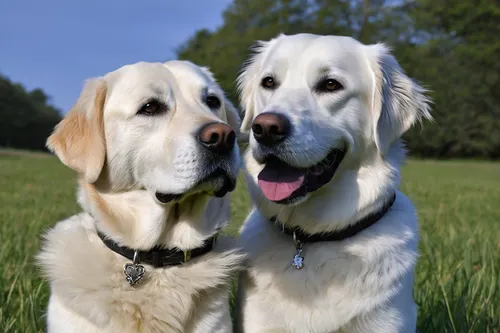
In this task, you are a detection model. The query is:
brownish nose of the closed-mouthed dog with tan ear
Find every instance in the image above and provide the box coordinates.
[198,123,236,154]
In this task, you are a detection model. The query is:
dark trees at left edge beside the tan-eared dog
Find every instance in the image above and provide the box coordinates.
[0,75,61,150]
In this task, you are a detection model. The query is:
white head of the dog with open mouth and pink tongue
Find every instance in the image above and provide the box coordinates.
[238,34,430,205]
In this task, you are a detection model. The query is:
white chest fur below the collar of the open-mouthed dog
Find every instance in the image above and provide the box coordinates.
[240,193,418,333]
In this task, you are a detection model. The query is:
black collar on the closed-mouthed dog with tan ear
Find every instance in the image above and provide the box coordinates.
[97,230,217,268]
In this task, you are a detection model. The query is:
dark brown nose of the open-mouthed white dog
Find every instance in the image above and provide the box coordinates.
[252,112,290,146]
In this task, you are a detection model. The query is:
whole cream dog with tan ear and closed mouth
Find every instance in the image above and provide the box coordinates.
[38,61,243,333]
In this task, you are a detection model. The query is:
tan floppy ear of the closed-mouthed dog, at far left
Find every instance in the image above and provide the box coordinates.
[47,79,107,183]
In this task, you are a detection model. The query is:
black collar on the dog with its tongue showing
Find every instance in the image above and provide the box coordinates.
[270,192,396,243]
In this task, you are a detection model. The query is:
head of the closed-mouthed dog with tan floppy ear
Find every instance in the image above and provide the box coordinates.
[47,61,240,204]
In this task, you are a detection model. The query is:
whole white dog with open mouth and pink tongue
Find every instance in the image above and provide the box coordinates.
[237,34,431,333]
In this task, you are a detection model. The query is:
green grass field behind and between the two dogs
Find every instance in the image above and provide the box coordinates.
[0,153,500,333]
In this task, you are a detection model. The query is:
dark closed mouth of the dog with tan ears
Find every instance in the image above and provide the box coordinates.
[155,168,236,204]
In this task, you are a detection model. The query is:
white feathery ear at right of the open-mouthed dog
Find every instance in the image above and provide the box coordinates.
[368,44,432,154]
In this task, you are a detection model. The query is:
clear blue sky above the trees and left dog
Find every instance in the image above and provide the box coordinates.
[0,0,231,112]
